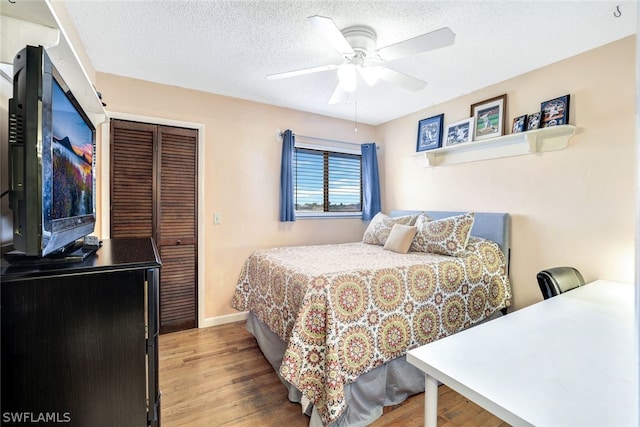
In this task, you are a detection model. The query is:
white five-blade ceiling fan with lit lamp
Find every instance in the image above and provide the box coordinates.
[267,15,456,104]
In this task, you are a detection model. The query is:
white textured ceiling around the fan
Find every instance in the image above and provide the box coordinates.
[64,0,636,125]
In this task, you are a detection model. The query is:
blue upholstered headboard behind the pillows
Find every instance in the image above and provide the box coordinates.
[390,210,511,274]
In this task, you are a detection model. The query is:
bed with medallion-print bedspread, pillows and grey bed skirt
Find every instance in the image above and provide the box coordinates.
[232,211,511,426]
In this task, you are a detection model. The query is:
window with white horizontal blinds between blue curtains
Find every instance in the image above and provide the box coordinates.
[293,147,362,213]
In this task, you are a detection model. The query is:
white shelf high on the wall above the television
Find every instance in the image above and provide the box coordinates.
[0,0,107,127]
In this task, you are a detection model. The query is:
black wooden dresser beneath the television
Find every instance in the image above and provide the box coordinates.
[0,238,161,427]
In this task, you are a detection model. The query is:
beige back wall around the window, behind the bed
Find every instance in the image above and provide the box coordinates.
[96,73,383,319]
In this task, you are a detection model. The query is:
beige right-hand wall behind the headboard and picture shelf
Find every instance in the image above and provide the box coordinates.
[378,37,636,308]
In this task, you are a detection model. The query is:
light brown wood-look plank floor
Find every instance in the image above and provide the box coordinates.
[159,322,508,427]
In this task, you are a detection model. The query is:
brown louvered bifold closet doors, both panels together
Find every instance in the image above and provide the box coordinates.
[110,119,198,333]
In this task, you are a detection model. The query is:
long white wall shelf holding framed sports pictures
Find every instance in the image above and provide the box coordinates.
[414,125,576,167]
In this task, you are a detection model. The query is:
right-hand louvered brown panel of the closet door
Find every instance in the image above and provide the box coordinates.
[157,126,198,332]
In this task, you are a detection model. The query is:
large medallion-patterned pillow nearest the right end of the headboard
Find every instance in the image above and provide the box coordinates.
[411,212,475,257]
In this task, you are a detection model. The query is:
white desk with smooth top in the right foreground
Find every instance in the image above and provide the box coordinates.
[407,280,640,427]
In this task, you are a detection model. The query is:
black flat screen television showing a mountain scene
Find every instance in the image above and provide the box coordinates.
[8,46,96,258]
